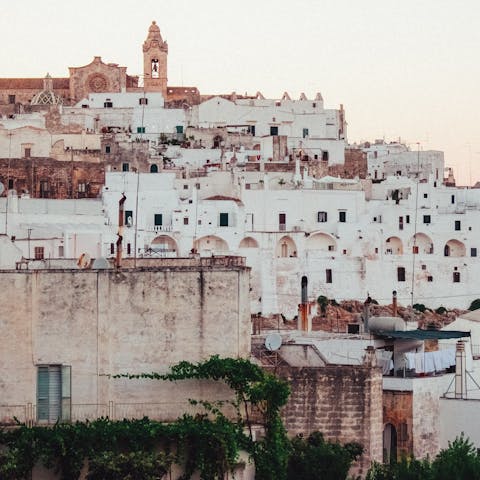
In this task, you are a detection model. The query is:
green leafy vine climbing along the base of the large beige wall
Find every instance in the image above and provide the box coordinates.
[0,356,290,480]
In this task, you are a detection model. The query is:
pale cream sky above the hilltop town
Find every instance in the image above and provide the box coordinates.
[0,0,480,185]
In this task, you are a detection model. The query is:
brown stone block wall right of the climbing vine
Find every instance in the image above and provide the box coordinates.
[278,365,382,475]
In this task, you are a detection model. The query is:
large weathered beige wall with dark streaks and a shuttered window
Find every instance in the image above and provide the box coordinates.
[0,259,250,420]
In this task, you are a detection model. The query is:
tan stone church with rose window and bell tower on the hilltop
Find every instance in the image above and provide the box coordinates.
[0,21,200,116]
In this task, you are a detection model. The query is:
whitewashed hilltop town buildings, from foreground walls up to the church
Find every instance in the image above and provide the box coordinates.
[0,22,480,479]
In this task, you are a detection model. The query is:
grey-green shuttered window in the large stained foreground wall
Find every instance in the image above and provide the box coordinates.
[37,365,72,423]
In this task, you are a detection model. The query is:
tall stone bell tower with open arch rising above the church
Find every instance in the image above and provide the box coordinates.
[143,21,168,100]
